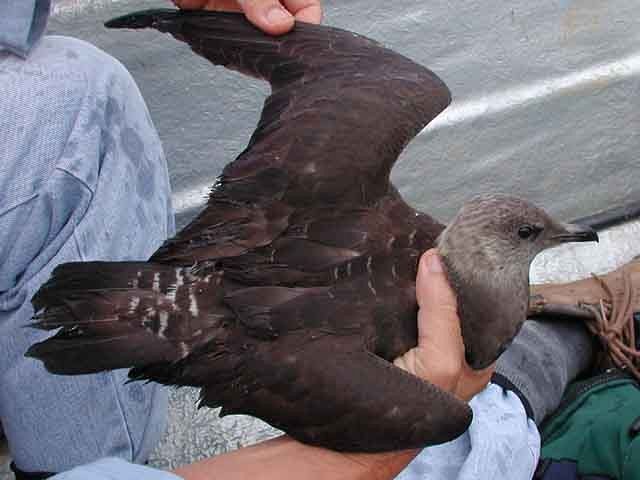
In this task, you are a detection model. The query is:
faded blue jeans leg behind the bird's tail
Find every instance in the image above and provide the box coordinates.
[0,36,174,472]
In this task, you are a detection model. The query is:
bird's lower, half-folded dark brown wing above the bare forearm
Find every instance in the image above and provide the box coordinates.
[203,332,471,451]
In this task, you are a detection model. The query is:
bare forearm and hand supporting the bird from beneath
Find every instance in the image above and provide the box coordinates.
[175,250,493,480]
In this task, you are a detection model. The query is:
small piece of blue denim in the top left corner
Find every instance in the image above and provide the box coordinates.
[0,0,51,57]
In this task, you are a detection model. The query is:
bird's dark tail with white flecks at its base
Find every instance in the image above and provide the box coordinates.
[26,262,231,375]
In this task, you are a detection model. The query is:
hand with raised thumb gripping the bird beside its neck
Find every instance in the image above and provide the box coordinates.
[393,249,495,401]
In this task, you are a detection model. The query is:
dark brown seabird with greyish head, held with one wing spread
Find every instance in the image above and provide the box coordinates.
[26,10,597,452]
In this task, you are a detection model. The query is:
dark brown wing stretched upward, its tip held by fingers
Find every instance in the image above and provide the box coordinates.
[107,10,450,261]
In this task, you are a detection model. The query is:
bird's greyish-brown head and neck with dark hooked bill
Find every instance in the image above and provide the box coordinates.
[438,194,598,368]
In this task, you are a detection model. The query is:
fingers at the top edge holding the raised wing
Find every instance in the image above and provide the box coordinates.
[173,0,322,35]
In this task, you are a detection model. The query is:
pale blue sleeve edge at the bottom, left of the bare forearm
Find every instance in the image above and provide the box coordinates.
[51,457,181,480]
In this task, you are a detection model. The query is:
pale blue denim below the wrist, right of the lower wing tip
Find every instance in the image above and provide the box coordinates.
[397,383,540,480]
